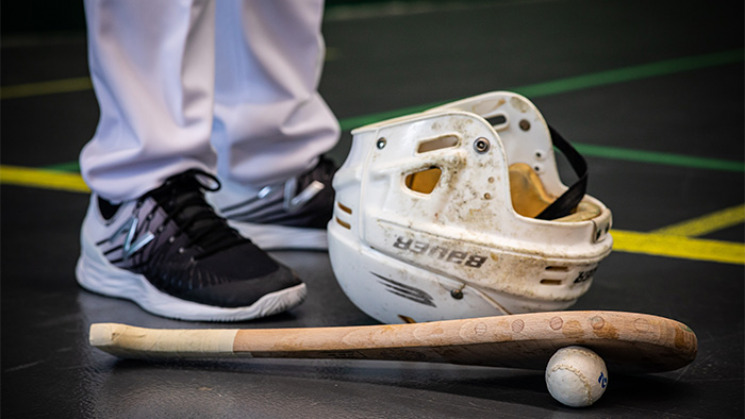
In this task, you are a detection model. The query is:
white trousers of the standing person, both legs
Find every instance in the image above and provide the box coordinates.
[80,0,339,202]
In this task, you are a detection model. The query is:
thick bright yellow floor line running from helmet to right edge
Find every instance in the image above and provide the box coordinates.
[611,230,745,265]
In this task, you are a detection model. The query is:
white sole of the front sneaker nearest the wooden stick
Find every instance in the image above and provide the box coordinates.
[75,230,307,322]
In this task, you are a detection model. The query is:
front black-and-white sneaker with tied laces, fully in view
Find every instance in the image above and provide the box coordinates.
[76,170,306,321]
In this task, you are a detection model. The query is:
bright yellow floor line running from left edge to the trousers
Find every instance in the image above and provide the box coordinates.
[0,165,90,192]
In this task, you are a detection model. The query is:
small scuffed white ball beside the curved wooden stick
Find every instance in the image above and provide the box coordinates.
[546,346,608,407]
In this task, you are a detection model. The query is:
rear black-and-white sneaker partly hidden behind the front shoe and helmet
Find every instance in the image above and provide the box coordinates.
[207,156,336,250]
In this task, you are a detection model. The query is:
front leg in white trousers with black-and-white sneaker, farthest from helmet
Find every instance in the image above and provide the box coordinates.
[76,0,306,321]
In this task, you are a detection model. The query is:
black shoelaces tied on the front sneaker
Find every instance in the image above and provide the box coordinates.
[147,169,248,260]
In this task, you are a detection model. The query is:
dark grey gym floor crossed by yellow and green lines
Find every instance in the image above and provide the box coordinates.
[0,0,745,418]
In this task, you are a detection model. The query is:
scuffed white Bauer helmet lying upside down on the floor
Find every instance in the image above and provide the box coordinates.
[328,92,612,323]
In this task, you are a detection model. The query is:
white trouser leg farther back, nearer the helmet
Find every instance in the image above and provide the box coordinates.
[212,0,339,192]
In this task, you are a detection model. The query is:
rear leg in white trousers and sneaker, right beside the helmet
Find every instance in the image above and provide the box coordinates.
[210,0,339,248]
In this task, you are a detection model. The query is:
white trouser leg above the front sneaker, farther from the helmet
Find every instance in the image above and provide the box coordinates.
[80,0,215,201]
